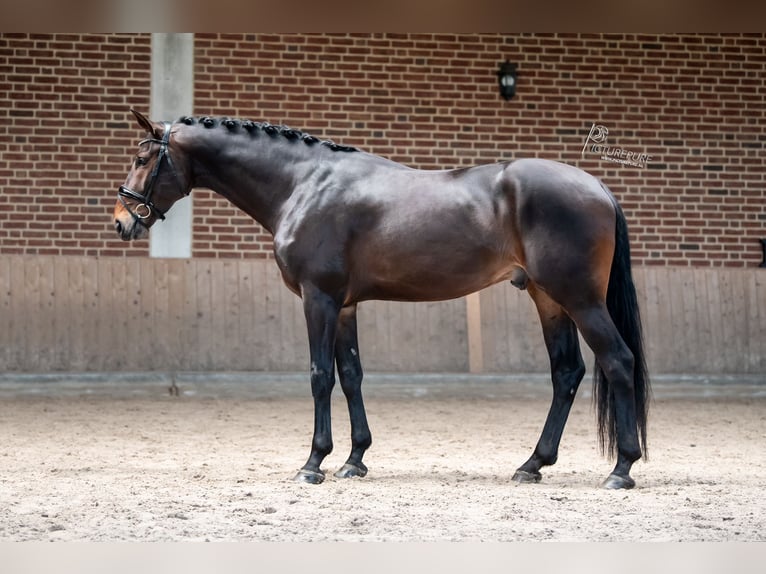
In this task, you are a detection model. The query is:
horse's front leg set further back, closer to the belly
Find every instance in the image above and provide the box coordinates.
[335,305,372,478]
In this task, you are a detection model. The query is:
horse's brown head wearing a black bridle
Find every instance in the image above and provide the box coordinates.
[114,109,191,241]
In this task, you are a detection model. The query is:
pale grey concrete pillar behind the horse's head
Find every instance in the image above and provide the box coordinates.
[149,33,194,258]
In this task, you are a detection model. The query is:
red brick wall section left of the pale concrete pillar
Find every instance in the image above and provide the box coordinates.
[0,34,151,255]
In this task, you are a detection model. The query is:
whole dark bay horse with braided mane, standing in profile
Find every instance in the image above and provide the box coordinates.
[114,111,649,488]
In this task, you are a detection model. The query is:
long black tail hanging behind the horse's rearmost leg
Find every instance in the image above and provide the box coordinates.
[593,187,651,458]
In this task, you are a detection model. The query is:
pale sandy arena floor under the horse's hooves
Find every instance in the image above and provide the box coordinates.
[0,374,766,542]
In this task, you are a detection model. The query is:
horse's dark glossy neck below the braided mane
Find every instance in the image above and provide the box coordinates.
[186,129,315,234]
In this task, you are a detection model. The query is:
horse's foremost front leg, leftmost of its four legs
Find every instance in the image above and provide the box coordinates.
[295,285,340,484]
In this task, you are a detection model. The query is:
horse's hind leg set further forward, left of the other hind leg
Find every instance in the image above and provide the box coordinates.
[513,284,585,483]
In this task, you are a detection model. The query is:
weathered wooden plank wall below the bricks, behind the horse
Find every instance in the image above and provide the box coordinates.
[0,255,766,377]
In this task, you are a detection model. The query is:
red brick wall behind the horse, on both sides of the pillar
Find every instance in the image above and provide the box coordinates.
[0,34,766,266]
